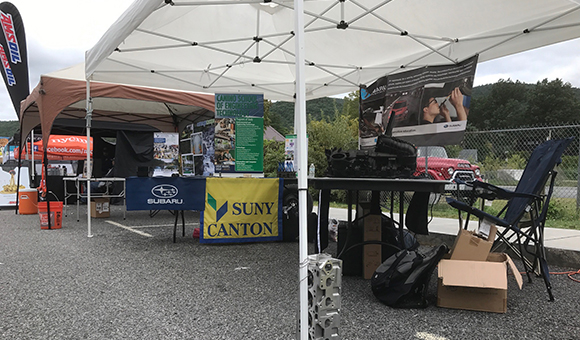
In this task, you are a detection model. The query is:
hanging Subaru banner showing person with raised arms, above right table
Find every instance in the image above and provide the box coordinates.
[359,56,477,149]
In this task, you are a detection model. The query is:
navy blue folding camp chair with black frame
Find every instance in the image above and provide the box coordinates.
[447,137,573,301]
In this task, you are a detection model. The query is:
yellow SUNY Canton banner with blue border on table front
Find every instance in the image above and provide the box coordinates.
[200,178,283,243]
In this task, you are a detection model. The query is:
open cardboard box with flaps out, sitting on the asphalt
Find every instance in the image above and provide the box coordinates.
[437,253,522,313]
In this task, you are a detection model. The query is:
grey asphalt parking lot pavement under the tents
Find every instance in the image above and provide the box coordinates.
[0,206,580,340]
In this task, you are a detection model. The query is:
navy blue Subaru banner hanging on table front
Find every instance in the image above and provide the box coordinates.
[125,177,205,211]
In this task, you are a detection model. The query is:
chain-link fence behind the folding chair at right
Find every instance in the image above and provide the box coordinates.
[381,125,580,213]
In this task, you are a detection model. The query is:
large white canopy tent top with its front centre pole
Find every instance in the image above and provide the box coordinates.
[86,0,580,339]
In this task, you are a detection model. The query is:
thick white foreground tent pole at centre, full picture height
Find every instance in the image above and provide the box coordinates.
[294,0,308,340]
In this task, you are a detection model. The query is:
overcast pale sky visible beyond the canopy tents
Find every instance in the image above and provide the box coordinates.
[0,0,580,120]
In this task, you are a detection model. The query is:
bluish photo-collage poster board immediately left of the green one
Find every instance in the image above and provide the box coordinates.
[179,119,215,176]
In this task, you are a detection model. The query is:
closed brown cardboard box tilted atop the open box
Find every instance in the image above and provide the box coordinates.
[451,224,497,261]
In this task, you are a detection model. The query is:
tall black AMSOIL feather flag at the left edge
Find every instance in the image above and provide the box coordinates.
[0,2,30,117]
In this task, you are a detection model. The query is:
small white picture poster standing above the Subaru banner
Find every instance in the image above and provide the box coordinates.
[153,132,179,177]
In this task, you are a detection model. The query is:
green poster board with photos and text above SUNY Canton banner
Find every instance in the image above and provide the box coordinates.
[215,94,264,173]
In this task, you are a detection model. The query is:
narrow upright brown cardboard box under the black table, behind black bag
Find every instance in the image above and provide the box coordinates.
[363,214,382,280]
